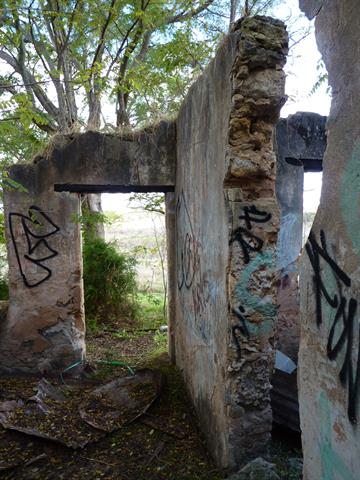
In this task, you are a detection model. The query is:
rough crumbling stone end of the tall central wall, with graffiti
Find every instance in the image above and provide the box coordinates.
[225,20,287,463]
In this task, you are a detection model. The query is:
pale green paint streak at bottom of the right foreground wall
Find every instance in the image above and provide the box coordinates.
[318,392,358,480]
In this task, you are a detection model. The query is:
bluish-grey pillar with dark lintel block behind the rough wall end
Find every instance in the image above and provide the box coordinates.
[275,112,326,362]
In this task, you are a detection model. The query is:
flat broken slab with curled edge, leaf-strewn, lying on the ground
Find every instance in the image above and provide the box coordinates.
[0,369,164,449]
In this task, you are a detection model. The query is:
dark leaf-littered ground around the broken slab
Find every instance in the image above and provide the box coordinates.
[0,334,223,480]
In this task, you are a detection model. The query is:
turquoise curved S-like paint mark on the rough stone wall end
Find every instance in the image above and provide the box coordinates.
[236,251,276,335]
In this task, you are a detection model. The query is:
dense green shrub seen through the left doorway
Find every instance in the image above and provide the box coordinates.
[83,236,138,330]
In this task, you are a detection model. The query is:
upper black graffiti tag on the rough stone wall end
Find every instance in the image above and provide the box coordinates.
[230,205,271,263]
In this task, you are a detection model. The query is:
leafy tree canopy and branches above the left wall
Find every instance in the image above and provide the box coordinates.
[0,0,284,161]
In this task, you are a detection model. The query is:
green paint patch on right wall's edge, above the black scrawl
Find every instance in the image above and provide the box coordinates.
[340,143,360,257]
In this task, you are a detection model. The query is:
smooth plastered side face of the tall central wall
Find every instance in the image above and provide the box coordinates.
[172,34,238,466]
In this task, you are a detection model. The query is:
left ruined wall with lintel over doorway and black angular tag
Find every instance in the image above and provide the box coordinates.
[0,122,175,372]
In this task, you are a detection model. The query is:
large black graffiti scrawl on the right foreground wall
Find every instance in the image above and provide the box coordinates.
[305,231,360,424]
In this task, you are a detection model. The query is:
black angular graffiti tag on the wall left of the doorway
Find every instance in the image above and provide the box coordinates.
[9,206,60,288]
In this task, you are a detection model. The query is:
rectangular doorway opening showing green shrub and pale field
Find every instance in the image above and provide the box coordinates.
[82,192,168,366]
